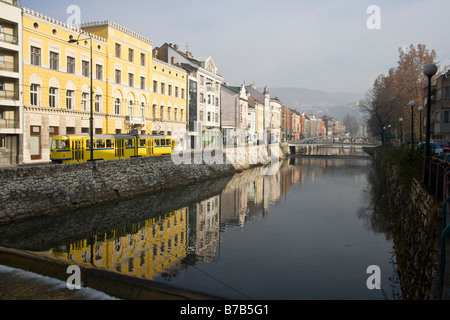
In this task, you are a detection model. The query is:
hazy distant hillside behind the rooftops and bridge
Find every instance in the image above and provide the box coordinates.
[266,88,364,121]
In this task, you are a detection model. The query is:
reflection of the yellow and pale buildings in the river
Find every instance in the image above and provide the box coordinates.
[49,158,372,279]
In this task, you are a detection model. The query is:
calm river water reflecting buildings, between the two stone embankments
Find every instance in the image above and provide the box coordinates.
[0,152,401,300]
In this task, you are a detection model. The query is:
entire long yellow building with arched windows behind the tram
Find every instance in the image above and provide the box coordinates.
[19,9,187,162]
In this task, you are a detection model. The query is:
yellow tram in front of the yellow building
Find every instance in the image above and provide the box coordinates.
[50,134,176,163]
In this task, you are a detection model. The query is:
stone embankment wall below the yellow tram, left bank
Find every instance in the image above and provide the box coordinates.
[0,146,284,222]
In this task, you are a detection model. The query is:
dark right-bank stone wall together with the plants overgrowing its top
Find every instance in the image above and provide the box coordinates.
[374,148,441,300]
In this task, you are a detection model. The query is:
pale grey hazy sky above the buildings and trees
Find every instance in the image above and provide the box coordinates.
[21,0,450,94]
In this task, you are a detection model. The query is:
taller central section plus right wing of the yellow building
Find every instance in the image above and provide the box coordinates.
[81,21,187,139]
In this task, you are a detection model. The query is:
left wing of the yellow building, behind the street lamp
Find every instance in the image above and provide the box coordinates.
[22,9,108,162]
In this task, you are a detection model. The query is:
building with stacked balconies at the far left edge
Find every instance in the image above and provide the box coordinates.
[0,0,23,165]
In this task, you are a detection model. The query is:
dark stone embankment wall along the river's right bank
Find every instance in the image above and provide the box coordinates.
[384,162,442,300]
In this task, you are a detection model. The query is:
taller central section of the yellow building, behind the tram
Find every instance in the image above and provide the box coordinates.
[81,21,153,134]
